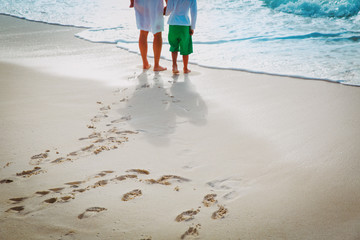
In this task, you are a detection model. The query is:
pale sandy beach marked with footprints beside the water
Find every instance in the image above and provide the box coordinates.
[0,16,360,240]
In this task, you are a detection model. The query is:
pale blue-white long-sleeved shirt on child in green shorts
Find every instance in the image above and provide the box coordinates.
[165,0,197,29]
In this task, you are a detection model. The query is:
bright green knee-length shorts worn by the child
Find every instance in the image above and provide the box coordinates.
[168,25,193,55]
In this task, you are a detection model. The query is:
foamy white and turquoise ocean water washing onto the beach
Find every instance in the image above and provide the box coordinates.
[0,0,360,86]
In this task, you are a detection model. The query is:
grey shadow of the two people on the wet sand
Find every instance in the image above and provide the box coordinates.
[120,71,207,145]
